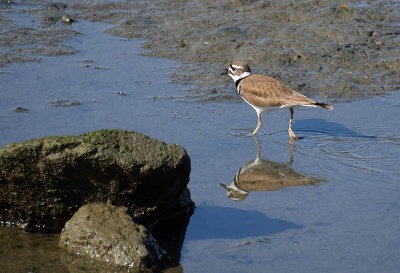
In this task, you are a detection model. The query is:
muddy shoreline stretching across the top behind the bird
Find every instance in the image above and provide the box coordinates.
[0,0,400,102]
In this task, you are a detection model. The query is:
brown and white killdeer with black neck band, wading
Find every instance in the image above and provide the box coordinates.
[227,62,333,140]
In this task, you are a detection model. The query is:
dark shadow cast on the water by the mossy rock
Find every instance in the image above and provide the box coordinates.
[186,206,303,241]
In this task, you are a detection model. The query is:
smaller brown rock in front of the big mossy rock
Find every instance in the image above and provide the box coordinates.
[59,203,165,268]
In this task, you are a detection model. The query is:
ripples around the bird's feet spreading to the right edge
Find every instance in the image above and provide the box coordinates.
[228,119,400,199]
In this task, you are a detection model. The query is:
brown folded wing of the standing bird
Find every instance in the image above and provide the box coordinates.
[239,74,315,107]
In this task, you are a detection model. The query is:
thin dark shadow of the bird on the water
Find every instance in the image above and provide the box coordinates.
[293,119,377,138]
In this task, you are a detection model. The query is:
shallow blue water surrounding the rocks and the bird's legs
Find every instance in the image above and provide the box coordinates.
[0,16,400,272]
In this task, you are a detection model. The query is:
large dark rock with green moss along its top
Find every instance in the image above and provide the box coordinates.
[0,130,193,231]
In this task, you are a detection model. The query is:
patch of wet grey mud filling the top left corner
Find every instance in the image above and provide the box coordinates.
[0,0,79,66]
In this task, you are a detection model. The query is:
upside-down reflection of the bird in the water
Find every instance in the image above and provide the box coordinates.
[220,137,319,201]
